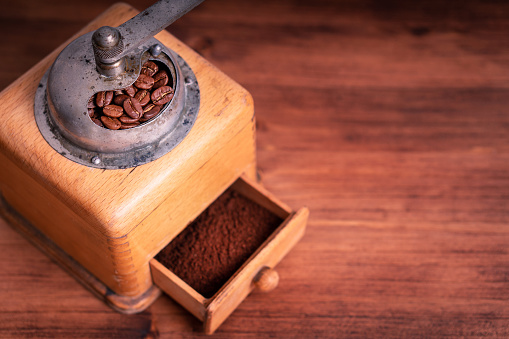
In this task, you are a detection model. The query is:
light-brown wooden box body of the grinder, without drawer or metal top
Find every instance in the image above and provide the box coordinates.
[0,4,256,312]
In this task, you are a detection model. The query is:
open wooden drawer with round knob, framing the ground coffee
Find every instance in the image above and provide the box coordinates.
[150,177,309,334]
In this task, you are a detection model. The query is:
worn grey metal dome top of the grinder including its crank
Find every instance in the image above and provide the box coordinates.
[34,0,201,169]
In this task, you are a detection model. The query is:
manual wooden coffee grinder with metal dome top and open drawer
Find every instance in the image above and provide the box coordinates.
[0,0,308,333]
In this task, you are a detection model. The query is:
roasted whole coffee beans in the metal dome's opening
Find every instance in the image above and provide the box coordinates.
[87,61,173,130]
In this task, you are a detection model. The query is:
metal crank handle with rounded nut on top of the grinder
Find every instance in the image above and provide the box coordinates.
[92,0,203,76]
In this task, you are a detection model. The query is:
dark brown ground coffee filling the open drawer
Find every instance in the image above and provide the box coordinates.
[156,190,283,298]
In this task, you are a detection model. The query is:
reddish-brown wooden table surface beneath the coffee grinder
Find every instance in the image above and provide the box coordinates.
[0,0,509,338]
